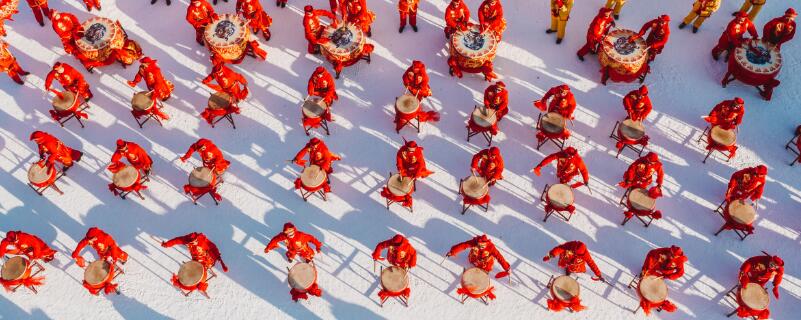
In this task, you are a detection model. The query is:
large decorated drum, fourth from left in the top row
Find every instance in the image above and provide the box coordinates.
[450,25,500,69]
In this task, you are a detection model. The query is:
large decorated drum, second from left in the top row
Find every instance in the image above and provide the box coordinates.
[203,14,250,61]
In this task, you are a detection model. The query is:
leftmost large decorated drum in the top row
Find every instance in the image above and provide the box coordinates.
[75,17,125,61]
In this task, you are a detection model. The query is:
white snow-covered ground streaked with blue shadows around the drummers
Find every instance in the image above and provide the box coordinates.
[0,0,801,319]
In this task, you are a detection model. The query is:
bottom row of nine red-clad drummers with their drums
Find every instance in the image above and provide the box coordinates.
[0,222,784,319]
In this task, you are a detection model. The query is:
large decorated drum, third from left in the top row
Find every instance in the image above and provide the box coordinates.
[320,23,366,62]
